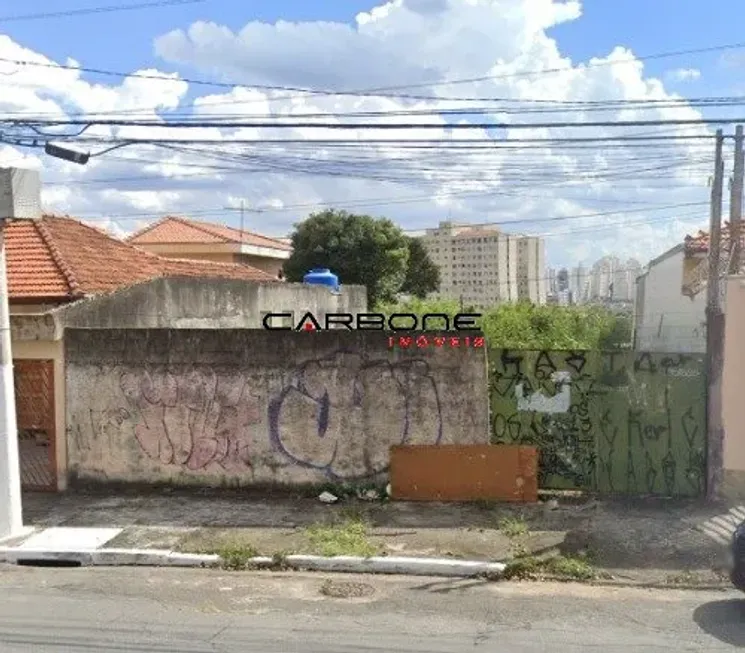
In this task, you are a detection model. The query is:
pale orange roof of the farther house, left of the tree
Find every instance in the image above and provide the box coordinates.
[127,216,292,252]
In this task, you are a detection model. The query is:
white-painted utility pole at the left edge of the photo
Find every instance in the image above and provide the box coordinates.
[0,219,23,539]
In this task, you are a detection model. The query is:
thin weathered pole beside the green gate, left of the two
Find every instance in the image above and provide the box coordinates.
[706,128,724,499]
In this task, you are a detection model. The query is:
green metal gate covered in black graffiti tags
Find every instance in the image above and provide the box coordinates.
[489,349,706,496]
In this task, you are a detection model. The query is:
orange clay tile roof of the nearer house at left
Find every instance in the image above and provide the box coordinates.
[5,216,276,301]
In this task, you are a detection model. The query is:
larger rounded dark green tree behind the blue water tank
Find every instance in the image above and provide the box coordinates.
[284,209,409,306]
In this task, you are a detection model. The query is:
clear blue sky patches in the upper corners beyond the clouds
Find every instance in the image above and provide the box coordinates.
[0,0,745,95]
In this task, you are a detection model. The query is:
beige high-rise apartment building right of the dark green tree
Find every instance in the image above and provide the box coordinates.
[422,222,546,306]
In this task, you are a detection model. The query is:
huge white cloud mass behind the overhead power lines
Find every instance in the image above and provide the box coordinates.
[0,0,713,264]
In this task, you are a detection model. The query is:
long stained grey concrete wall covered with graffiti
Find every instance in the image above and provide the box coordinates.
[65,329,489,485]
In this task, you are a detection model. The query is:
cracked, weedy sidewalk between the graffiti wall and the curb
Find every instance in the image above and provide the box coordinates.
[24,490,730,574]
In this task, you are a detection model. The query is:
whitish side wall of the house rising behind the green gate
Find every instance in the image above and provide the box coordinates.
[635,247,706,354]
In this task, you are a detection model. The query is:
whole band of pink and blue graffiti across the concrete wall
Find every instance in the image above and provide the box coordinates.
[77,351,444,480]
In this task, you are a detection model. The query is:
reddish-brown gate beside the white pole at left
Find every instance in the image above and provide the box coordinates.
[13,360,57,491]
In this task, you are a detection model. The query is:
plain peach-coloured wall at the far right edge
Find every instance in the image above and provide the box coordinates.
[722,277,745,500]
